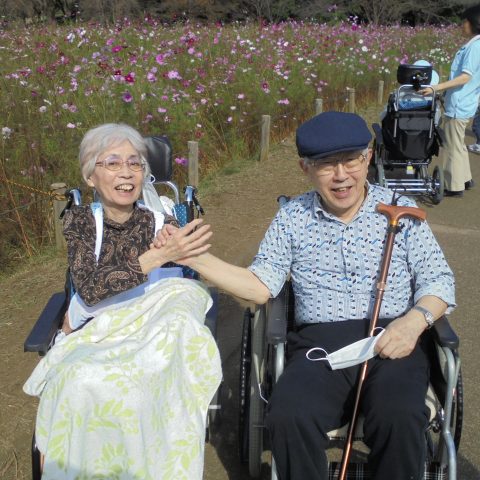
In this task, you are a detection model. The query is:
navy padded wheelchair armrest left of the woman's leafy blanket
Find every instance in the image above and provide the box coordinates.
[23,292,67,355]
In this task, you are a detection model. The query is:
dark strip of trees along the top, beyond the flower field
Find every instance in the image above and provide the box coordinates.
[0,0,477,25]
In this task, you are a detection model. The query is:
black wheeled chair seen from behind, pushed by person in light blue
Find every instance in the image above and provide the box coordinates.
[372,62,444,204]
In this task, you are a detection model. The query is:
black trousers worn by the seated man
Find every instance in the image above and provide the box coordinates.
[266,320,429,480]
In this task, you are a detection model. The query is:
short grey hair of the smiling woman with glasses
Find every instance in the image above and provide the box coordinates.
[78,123,150,181]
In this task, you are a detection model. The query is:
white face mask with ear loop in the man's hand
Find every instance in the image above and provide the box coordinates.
[305,327,385,370]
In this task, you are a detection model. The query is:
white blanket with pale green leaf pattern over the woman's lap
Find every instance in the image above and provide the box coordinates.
[24,279,222,480]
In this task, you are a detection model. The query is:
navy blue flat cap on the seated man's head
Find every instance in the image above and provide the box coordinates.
[297,112,372,160]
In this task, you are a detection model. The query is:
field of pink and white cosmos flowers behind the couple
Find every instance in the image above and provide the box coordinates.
[0,18,462,262]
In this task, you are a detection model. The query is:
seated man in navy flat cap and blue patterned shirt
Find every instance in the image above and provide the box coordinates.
[167,112,455,480]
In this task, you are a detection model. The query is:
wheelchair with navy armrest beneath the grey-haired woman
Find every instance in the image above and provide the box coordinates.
[24,136,222,480]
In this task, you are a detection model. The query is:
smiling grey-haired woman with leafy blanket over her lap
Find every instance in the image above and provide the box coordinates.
[24,124,221,479]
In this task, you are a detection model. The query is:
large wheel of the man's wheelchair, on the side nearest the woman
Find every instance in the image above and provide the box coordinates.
[248,305,267,478]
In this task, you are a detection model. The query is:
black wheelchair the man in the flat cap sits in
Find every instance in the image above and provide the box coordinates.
[239,209,463,480]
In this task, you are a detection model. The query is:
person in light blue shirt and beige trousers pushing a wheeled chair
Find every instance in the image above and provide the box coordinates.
[421,5,480,197]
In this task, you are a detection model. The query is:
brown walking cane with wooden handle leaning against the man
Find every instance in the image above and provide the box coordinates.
[338,200,427,480]
